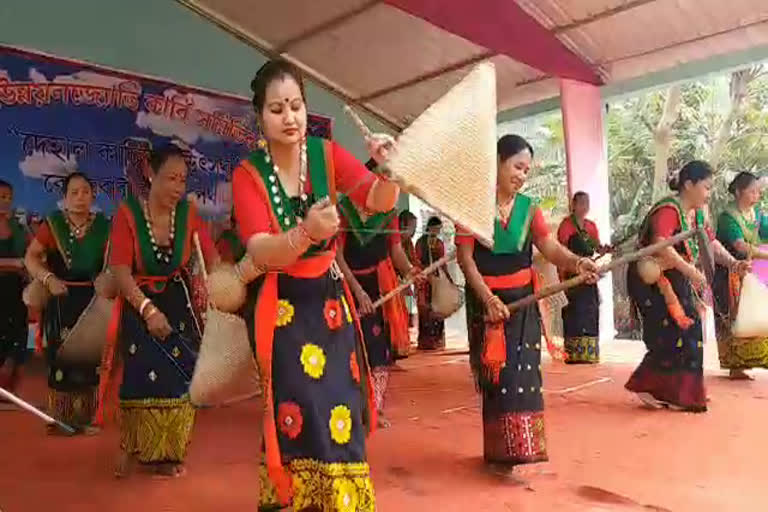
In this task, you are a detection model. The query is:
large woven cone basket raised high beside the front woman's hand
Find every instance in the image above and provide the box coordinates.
[387,62,497,247]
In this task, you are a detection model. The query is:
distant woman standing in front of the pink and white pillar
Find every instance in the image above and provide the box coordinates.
[557,192,608,364]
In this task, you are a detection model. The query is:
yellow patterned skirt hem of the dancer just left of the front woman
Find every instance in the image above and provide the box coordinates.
[120,397,195,464]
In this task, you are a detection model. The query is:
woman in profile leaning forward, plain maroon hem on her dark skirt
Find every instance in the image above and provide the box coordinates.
[625,160,747,412]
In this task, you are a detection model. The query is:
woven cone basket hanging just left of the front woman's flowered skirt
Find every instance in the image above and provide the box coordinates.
[189,308,261,407]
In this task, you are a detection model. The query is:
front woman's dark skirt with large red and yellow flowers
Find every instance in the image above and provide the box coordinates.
[244,272,375,512]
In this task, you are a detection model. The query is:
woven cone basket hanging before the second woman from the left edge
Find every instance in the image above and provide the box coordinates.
[56,293,114,366]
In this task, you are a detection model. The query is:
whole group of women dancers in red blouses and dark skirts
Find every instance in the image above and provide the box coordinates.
[0,60,768,511]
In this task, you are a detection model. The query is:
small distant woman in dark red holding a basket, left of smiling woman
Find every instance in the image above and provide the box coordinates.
[416,217,446,350]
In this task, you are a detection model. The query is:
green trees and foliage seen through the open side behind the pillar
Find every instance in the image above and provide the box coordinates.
[499,65,768,336]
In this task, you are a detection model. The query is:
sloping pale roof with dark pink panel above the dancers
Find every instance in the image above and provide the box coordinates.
[178,0,768,129]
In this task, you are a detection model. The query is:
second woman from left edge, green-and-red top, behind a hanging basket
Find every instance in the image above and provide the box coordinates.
[24,172,109,434]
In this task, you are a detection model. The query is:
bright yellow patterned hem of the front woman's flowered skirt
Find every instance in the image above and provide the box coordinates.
[259,459,376,512]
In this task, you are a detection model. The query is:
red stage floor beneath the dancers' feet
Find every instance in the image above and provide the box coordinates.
[0,342,768,512]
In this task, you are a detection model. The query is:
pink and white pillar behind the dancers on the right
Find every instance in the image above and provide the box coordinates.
[560,79,615,342]
